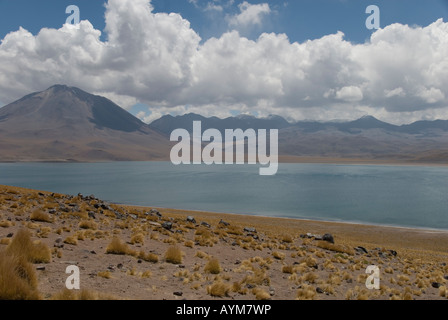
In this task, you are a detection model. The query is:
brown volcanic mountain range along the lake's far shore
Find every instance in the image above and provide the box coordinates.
[0,85,448,163]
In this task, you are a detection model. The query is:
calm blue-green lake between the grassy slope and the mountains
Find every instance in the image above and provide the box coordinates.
[0,162,448,229]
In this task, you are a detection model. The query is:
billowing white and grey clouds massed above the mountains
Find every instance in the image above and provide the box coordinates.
[0,0,448,123]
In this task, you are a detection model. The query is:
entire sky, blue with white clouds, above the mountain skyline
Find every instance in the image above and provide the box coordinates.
[0,0,448,124]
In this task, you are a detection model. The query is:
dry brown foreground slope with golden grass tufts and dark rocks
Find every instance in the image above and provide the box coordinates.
[0,186,448,300]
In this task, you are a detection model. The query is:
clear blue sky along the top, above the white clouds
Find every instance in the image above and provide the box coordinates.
[0,0,448,42]
